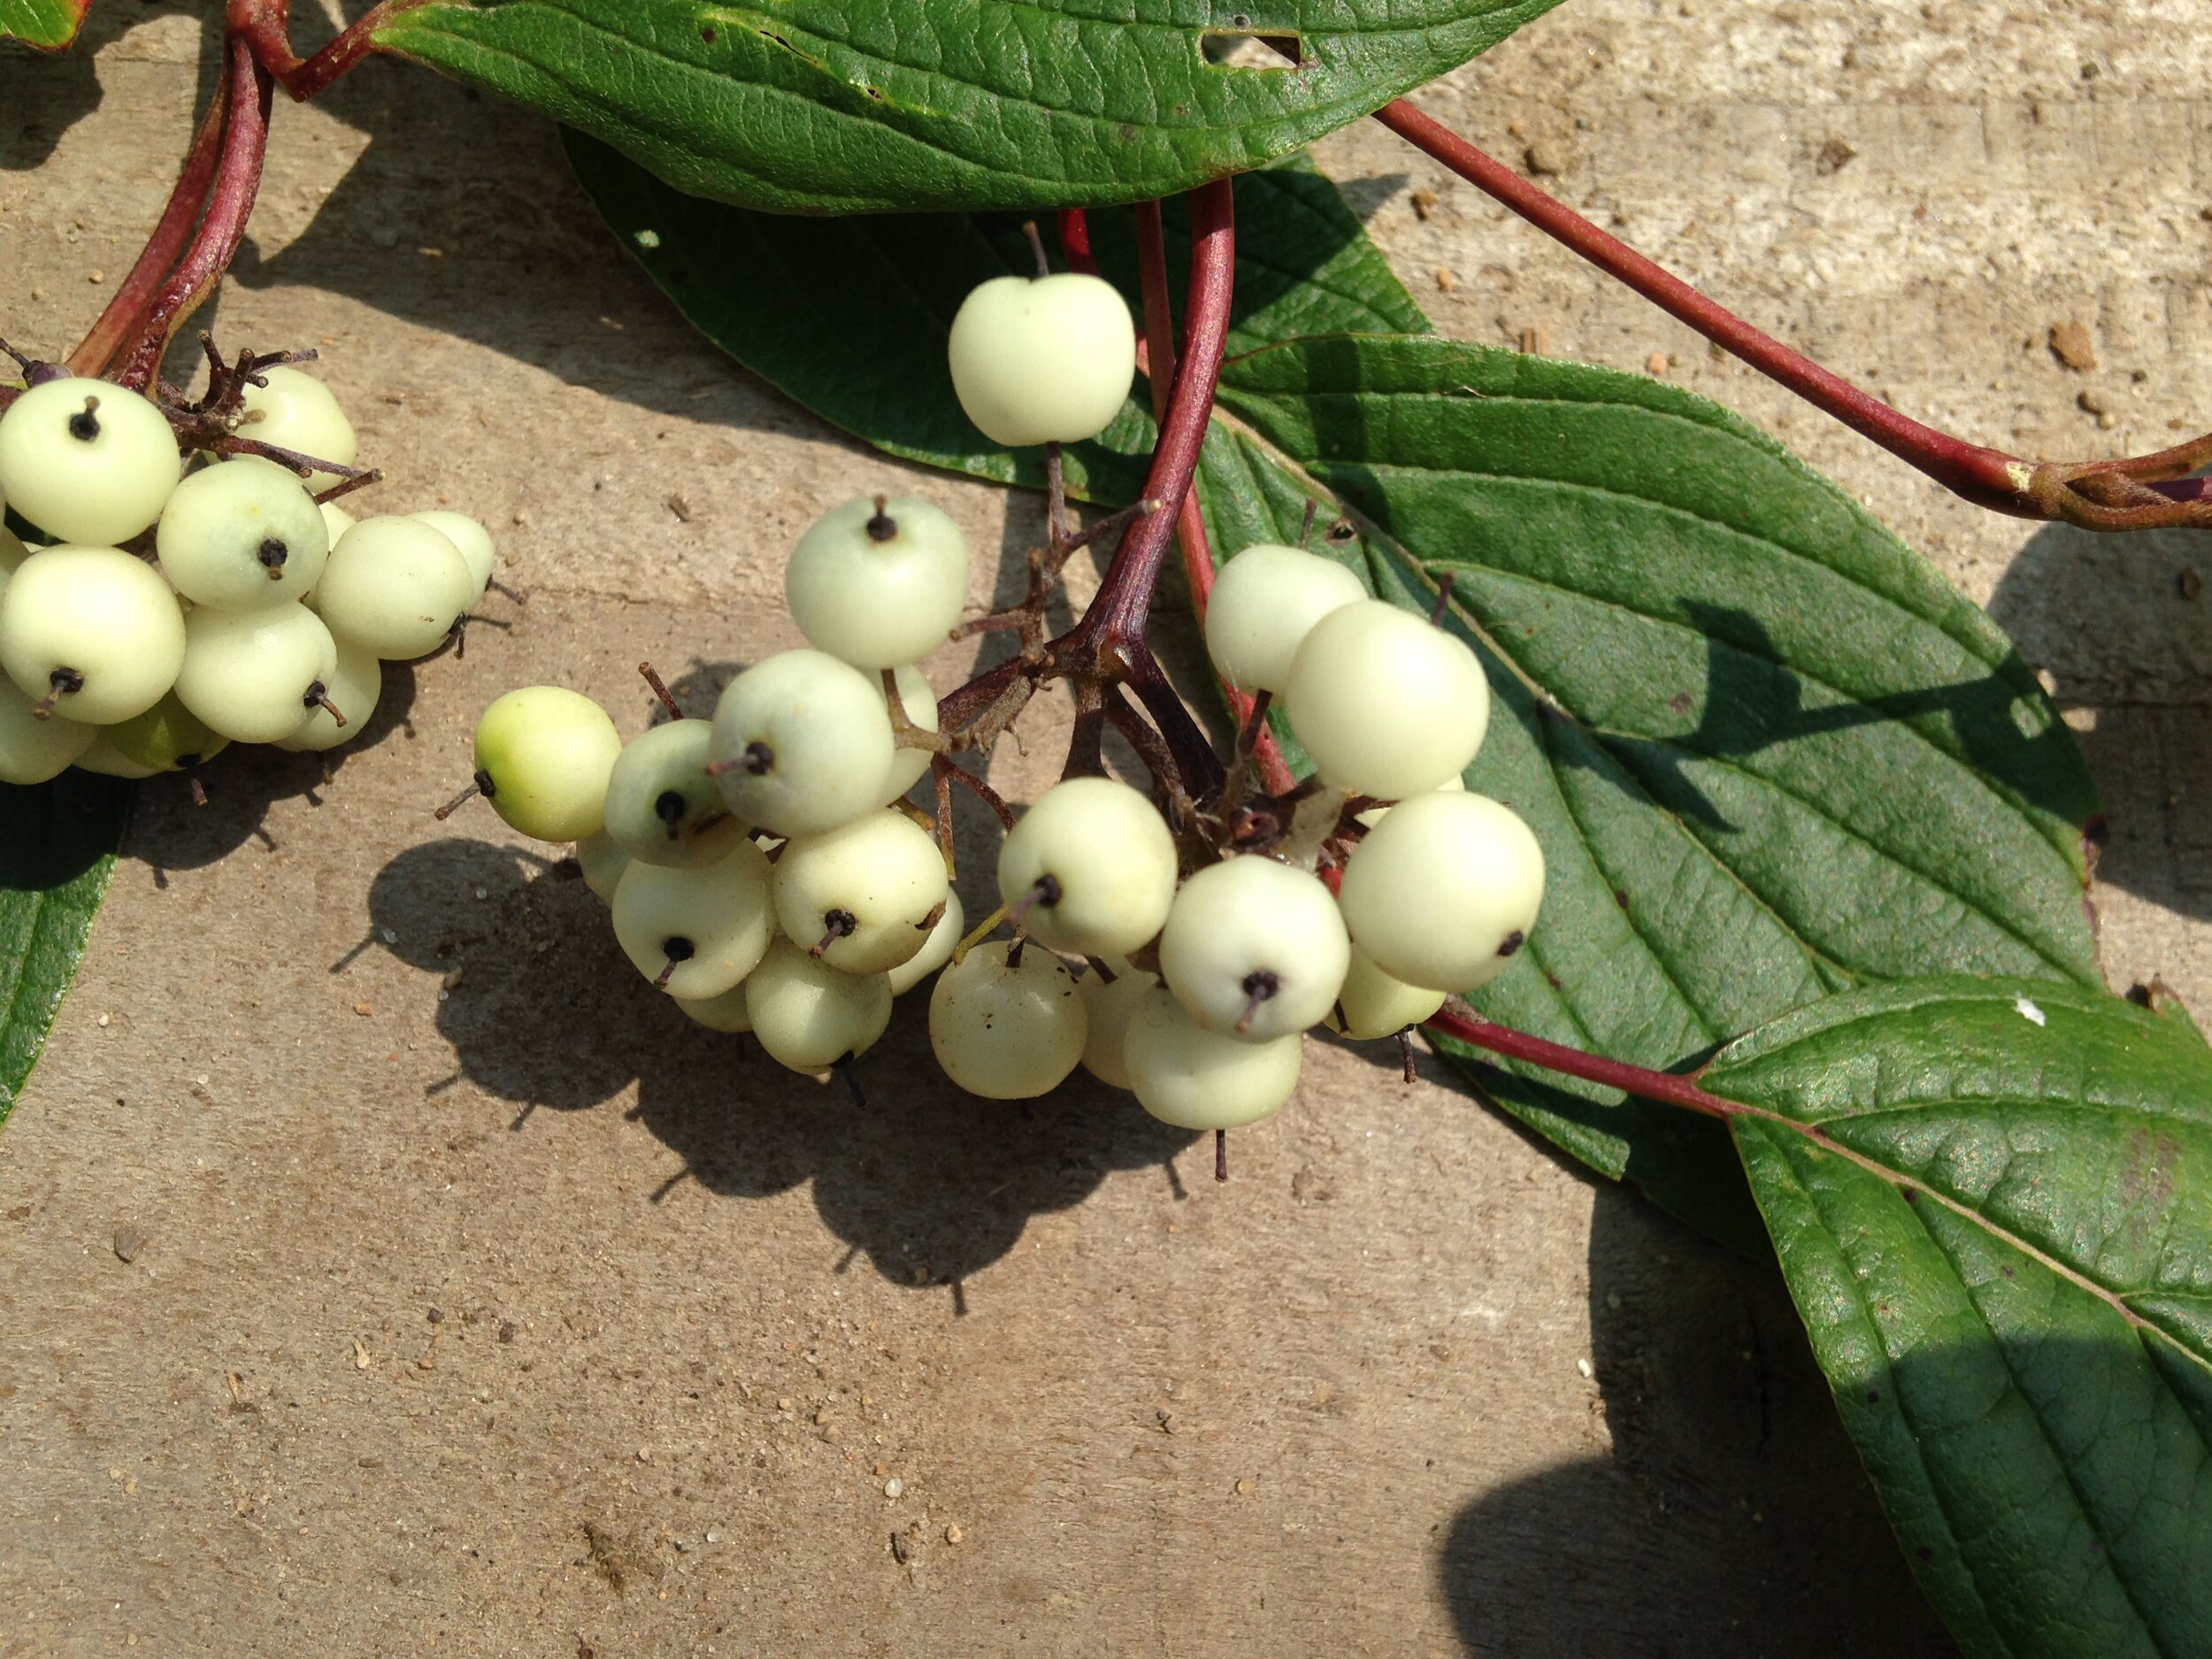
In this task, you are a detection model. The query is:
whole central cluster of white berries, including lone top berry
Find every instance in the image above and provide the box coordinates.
[438,263,1544,1159]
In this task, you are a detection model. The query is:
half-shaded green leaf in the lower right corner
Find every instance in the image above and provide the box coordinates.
[1703,978,2212,1659]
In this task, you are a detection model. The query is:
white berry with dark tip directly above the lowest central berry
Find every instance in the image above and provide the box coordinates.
[1159,854,1352,1042]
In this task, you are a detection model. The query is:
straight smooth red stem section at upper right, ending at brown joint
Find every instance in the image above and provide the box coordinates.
[1376,100,2047,518]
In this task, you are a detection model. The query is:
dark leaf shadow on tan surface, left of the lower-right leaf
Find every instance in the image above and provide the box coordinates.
[1436,1155,1958,1659]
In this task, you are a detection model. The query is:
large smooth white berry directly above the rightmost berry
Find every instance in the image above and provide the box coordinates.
[1283,600,1491,801]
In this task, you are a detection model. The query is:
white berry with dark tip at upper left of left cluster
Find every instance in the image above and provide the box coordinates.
[0,380,184,547]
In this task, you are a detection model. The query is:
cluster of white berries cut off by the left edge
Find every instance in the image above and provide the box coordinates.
[0,358,494,783]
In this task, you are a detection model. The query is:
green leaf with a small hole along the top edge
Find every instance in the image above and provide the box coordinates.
[376,0,1555,212]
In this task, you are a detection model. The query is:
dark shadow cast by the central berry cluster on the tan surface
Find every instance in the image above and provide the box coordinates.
[360,827,1194,1296]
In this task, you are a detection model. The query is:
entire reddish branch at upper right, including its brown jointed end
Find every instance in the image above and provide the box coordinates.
[1376,100,2212,531]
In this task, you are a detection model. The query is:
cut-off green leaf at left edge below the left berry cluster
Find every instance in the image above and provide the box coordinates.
[0,772,131,1124]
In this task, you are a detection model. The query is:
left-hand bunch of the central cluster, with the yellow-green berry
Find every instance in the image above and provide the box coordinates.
[453,495,969,1073]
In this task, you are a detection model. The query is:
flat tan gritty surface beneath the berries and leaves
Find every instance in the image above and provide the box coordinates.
[0,0,2212,1659]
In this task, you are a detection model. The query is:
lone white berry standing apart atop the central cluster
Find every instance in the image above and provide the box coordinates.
[947,273,1137,449]
